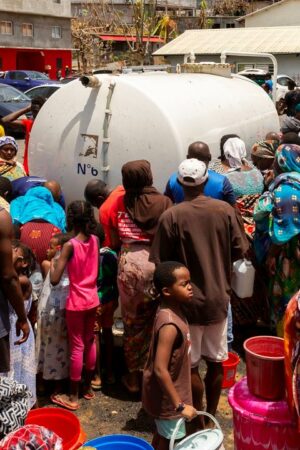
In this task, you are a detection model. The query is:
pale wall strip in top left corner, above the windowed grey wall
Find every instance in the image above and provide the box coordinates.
[0,0,71,17]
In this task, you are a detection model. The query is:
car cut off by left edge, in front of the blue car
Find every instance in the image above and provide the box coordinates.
[0,84,31,134]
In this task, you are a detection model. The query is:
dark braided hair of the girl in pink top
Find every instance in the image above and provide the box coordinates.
[67,200,97,236]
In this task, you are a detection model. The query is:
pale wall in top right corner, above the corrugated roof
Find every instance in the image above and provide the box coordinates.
[245,0,300,27]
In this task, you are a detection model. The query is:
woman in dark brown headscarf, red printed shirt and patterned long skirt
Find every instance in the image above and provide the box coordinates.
[109,160,172,393]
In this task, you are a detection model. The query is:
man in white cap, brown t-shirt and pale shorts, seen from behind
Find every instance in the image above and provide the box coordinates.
[150,159,246,426]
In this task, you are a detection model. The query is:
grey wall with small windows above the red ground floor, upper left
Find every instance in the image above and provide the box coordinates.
[0,12,72,48]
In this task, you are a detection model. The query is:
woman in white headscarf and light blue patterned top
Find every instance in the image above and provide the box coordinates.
[210,134,264,240]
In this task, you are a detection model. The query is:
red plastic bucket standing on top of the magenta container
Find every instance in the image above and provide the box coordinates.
[244,336,285,400]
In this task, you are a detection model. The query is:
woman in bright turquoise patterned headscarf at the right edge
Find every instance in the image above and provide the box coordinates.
[254,144,300,336]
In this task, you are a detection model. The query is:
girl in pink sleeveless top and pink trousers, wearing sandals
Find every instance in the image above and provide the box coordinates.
[50,201,99,411]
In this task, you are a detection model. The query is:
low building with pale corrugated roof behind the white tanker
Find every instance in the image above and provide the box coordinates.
[154,26,300,80]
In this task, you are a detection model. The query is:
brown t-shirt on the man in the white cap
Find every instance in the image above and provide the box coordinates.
[150,195,245,325]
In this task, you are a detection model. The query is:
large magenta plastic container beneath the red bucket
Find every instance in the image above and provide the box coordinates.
[228,377,300,450]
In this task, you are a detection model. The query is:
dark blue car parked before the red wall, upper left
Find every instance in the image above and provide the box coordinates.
[0,70,57,92]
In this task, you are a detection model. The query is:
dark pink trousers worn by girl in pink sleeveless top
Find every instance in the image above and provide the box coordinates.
[66,308,97,381]
